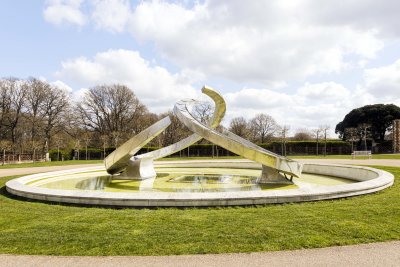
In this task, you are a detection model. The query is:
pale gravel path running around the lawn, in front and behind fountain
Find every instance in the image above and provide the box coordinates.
[0,159,400,267]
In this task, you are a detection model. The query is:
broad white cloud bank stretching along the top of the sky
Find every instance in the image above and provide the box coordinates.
[44,0,394,84]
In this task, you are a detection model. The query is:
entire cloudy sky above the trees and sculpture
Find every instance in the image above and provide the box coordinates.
[0,0,400,137]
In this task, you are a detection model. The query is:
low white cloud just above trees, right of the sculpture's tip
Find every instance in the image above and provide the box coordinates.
[224,82,368,137]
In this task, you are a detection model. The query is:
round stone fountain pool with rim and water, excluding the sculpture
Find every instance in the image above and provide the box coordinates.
[7,160,393,207]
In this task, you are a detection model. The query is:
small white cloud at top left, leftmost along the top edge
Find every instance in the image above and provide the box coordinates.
[43,0,86,26]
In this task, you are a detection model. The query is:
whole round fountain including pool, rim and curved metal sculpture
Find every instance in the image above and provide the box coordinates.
[6,87,394,207]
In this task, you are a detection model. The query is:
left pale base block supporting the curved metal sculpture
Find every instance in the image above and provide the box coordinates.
[118,157,157,180]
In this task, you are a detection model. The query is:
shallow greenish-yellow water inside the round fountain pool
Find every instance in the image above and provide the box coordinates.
[29,168,353,192]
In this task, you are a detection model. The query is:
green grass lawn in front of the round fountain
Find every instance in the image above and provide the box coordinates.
[0,167,400,255]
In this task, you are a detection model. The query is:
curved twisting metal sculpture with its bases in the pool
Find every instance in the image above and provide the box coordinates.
[105,86,302,184]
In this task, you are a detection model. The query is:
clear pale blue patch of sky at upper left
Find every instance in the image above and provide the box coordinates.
[0,0,137,79]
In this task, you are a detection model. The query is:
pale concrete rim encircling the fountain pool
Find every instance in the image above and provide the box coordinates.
[6,161,394,207]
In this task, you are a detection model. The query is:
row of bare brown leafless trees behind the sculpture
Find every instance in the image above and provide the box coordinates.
[0,78,336,158]
